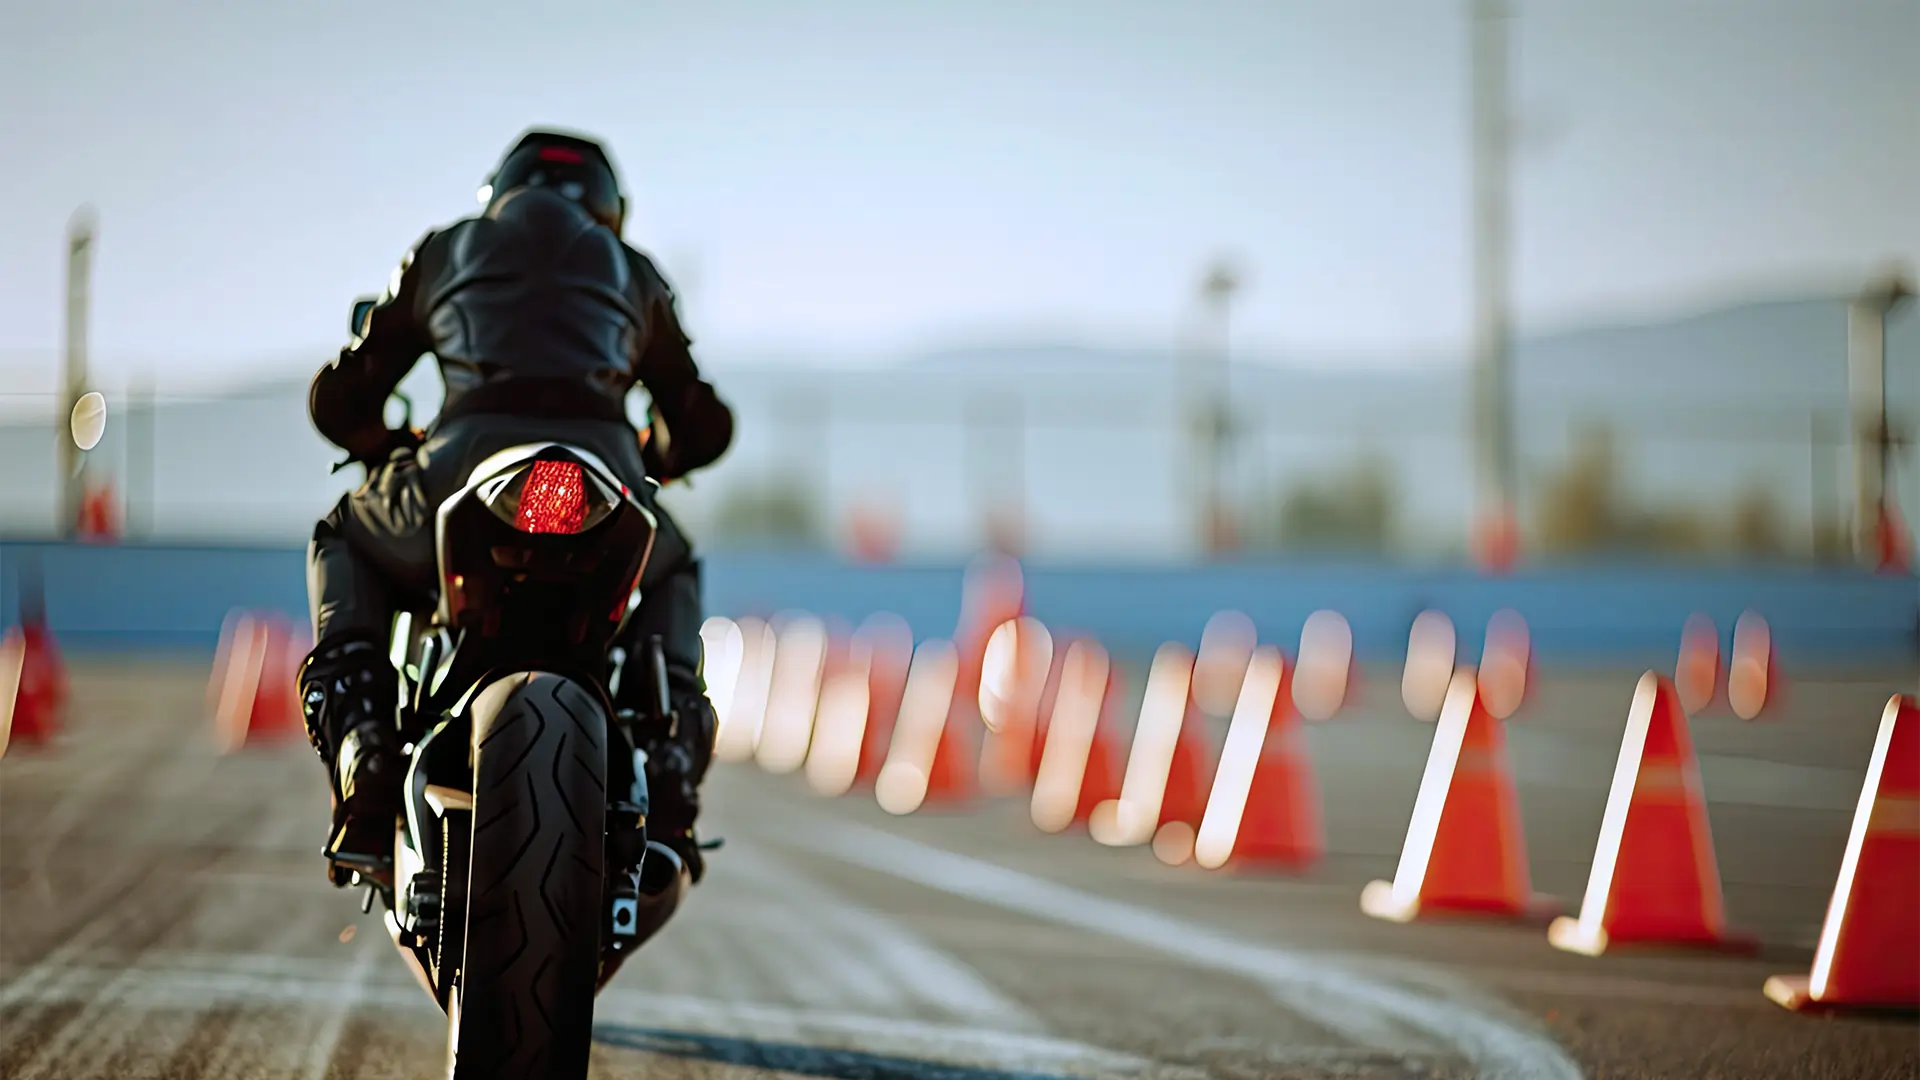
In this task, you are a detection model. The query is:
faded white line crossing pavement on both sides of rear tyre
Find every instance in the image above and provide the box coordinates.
[0,957,1169,1076]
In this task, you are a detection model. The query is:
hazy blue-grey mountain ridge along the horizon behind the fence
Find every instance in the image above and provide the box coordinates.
[0,290,1920,555]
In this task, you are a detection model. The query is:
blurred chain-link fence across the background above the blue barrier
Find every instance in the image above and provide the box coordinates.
[0,353,1920,561]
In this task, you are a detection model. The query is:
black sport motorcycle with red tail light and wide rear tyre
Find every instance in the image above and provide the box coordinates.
[328,300,689,1080]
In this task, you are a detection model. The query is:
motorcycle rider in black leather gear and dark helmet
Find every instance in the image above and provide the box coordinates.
[300,131,733,884]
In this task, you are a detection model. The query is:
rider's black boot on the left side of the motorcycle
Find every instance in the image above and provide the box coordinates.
[300,638,407,886]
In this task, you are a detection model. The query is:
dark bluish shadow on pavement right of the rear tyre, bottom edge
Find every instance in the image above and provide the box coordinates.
[593,1026,1105,1080]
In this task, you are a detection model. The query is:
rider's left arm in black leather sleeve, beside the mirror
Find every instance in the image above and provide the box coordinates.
[307,233,434,459]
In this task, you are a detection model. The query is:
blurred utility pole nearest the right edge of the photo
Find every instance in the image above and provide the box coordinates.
[1847,271,1914,569]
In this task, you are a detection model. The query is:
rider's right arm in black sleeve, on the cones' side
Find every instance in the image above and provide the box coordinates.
[628,248,733,480]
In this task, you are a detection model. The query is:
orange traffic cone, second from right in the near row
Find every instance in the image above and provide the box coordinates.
[1548,671,1753,957]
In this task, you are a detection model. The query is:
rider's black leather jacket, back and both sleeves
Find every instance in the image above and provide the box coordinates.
[307,188,733,479]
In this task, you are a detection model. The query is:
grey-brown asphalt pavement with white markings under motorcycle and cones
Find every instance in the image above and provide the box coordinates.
[0,661,1920,1080]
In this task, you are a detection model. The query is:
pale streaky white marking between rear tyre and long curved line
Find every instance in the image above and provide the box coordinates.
[726,847,1037,1030]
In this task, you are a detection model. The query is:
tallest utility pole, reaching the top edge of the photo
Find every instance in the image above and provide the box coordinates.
[1469,0,1519,571]
